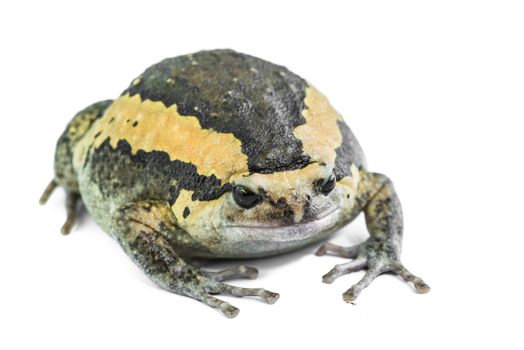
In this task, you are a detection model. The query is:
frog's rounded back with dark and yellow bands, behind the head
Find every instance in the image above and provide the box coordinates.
[74,50,364,230]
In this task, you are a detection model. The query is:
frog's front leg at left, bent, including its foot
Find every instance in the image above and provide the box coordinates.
[113,201,279,317]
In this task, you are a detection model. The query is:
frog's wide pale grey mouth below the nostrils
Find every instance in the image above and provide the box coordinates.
[226,207,340,242]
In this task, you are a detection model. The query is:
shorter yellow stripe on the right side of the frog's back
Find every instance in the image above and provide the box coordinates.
[293,85,342,167]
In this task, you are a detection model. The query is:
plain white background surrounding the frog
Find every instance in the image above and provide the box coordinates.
[0,0,524,349]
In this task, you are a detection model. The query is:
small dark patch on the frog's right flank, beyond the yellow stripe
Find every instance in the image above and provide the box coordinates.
[335,120,366,181]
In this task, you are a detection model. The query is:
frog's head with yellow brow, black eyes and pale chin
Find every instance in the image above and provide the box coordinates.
[184,163,358,257]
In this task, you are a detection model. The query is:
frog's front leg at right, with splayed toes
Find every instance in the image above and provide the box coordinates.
[316,173,430,302]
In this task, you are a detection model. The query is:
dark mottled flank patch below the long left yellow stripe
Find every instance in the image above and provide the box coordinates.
[88,138,231,205]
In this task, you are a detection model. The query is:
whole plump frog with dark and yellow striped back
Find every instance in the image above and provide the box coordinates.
[40,49,430,318]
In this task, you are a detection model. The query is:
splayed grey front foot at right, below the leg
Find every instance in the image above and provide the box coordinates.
[316,238,430,303]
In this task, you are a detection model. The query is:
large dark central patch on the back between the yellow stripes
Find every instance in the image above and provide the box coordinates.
[123,50,310,173]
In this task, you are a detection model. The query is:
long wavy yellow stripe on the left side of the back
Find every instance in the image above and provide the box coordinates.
[74,94,247,182]
